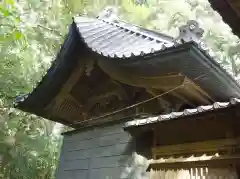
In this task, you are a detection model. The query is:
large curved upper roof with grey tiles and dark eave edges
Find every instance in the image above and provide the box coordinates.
[15,17,240,125]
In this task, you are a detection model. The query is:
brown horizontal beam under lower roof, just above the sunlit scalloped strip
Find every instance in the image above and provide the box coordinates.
[152,138,239,156]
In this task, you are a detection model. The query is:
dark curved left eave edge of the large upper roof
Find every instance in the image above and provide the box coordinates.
[14,23,82,113]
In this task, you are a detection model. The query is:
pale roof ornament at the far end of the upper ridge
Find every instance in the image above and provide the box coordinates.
[97,6,119,22]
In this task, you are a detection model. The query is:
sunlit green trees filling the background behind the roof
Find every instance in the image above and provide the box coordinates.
[0,0,240,179]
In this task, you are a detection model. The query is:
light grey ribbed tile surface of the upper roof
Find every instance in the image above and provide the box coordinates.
[74,17,174,58]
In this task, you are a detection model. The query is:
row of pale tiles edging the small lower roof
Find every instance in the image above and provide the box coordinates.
[124,98,240,128]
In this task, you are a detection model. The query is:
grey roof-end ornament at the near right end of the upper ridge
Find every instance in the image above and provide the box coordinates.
[175,20,204,44]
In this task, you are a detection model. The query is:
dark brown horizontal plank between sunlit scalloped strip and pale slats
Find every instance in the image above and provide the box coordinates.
[147,155,240,171]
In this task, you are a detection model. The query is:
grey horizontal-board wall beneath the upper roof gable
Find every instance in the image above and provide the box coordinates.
[56,124,148,179]
